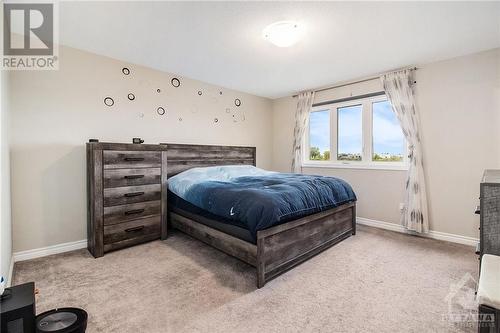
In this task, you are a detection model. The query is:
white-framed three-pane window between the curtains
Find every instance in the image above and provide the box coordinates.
[304,96,407,169]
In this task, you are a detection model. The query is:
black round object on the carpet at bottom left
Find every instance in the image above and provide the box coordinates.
[36,308,87,333]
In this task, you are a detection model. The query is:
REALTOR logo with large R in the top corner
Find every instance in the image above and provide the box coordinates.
[1,2,58,70]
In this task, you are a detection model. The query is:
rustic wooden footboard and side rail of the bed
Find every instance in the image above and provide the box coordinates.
[170,202,356,288]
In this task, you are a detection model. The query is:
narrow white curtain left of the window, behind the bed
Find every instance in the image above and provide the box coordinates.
[292,91,314,173]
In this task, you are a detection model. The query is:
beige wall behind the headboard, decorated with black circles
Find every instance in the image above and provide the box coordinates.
[11,47,272,252]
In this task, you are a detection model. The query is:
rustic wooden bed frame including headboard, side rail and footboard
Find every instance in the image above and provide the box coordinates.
[163,143,356,288]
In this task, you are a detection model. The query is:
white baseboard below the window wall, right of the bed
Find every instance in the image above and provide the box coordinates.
[356,217,479,247]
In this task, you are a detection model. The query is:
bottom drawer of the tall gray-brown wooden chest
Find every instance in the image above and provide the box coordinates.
[103,216,161,244]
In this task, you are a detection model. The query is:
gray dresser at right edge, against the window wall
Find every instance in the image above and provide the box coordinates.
[479,170,500,258]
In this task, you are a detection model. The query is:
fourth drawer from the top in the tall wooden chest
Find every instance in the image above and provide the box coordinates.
[104,201,161,225]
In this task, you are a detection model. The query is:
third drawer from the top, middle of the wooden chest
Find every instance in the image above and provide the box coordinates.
[104,184,161,207]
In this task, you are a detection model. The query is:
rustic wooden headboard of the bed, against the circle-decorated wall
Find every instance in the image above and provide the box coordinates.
[162,143,256,177]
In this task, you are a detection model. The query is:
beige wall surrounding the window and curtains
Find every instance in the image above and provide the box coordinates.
[273,49,500,237]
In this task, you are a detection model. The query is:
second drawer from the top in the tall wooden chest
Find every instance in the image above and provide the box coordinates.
[104,168,161,188]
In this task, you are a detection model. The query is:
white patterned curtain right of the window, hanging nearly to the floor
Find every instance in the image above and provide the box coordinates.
[380,69,429,233]
